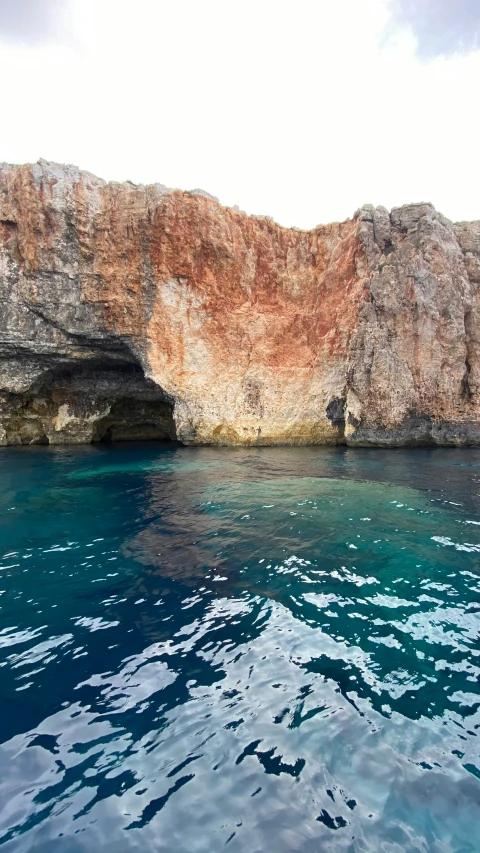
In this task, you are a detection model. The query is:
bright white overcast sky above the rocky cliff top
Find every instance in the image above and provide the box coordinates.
[0,0,480,228]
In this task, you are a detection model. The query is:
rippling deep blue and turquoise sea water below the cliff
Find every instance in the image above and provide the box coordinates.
[0,446,480,853]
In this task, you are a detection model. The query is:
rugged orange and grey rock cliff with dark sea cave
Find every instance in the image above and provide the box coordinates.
[0,161,480,445]
